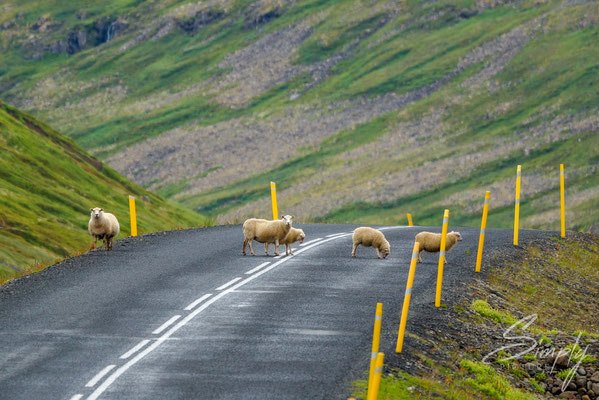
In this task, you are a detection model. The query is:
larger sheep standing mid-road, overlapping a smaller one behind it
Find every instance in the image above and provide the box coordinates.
[242,215,295,256]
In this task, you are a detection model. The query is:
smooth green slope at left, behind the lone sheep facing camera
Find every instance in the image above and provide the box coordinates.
[0,103,209,281]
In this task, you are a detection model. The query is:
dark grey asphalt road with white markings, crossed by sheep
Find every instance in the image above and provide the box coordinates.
[0,225,544,400]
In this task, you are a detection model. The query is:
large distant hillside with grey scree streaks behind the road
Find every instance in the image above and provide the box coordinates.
[0,0,599,229]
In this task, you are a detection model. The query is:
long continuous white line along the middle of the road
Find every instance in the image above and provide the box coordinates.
[87,231,346,400]
